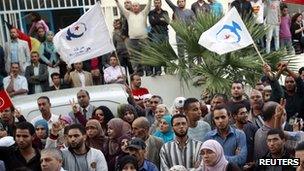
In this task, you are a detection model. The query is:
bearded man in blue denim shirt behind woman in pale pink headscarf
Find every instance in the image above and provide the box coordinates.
[205,105,247,166]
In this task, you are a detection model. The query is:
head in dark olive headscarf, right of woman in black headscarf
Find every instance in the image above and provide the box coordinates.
[117,104,137,125]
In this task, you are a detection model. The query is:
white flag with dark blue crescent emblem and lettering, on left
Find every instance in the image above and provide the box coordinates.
[53,3,115,64]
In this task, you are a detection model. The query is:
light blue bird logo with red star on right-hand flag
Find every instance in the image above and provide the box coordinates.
[216,21,242,43]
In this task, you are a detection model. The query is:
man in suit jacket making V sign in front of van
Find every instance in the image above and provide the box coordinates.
[69,90,95,126]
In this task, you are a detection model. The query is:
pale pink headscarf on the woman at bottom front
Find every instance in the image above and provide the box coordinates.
[201,140,228,171]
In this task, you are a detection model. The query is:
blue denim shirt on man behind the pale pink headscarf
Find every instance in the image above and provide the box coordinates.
[205,126,247,166]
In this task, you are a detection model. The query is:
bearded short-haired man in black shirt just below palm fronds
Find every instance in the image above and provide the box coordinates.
[227,80,250,110]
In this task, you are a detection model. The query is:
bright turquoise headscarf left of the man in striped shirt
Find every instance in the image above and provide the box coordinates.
[153,114,174,143]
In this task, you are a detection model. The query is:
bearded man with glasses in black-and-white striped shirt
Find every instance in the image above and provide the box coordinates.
[159,114,202,171]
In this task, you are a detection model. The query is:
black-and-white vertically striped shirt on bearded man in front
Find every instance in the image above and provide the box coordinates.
[160,138,203,171]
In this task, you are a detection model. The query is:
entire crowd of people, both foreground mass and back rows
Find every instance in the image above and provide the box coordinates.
[0,0,304,171]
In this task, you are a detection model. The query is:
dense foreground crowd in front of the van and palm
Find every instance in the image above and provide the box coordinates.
[0,62,304,171]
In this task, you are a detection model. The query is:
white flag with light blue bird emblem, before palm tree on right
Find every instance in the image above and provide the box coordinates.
[198,7,253,55]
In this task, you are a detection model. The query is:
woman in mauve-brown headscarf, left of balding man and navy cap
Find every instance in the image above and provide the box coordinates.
[106,118,131,170]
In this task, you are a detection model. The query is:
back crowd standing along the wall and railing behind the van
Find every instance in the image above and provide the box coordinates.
[0,0,304,97]
